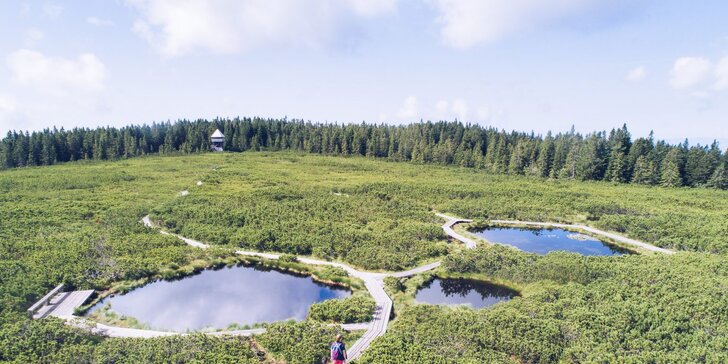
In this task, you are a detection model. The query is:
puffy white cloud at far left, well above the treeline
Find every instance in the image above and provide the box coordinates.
[6,49,106,94]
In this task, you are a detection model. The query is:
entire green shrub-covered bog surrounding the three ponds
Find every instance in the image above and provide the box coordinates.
[0,150,728,363]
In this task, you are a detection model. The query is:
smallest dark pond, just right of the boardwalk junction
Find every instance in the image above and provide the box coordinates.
[415,278,518,308]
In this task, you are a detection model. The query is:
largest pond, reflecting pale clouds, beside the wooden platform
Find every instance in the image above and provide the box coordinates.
[90,266,351,331]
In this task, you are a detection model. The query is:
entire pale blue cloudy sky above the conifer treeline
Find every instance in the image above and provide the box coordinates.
[0,0,728,147]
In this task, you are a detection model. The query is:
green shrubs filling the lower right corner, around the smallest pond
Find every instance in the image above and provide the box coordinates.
[362,246,728,363]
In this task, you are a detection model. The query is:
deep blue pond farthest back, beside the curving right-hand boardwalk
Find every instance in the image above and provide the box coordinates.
[473,227,627,255]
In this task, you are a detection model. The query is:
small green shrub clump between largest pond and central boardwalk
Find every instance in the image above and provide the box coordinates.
[308,293,376,324]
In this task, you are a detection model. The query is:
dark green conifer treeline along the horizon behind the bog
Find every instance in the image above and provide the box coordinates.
[0,118,728,189]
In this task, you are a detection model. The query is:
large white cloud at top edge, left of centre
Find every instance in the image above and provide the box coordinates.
[127,0,397,56]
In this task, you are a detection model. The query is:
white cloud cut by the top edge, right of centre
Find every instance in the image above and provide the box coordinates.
[430,0,610,48]
